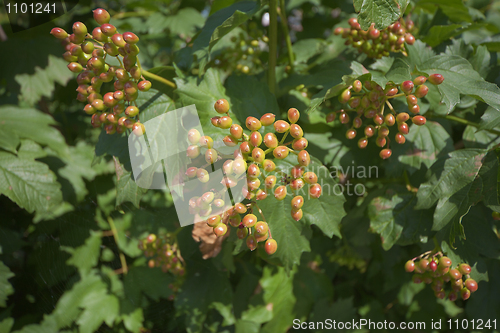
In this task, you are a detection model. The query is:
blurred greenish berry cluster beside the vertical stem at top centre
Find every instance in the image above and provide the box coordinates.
[209,26,269,74]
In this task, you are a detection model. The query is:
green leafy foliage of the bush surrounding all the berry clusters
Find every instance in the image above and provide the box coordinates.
[0,0,500,333]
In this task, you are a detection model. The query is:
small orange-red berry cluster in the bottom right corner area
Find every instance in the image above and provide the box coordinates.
[405,252,477,301]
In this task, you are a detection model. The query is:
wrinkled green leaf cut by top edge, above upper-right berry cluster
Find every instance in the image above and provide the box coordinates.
[354,0,406,30]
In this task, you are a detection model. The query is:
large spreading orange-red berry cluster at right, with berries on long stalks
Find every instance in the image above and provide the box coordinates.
[326,74,444,159]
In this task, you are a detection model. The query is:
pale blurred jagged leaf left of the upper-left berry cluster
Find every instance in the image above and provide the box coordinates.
[15,55,74,105]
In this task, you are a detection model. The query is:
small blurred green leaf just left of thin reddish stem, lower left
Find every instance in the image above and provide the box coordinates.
[63,230,102,276]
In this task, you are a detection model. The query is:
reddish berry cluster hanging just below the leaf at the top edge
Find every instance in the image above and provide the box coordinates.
[334,18,415,59]
